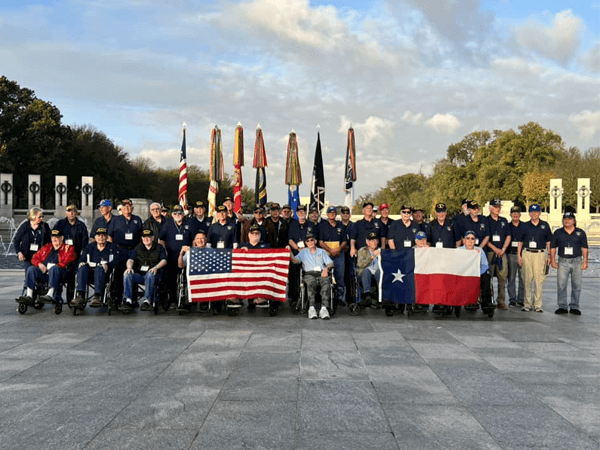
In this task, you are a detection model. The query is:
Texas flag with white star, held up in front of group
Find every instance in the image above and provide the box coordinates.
[381,247,480,306]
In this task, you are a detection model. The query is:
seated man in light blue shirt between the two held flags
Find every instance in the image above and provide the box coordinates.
[290,233,333,320]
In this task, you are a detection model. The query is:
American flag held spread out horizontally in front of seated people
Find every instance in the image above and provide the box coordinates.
[187,248,290,302]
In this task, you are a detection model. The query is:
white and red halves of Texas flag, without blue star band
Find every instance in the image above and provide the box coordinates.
[415,247,485,306]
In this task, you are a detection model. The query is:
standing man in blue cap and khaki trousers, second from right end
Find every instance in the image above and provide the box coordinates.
[517,203,552,313]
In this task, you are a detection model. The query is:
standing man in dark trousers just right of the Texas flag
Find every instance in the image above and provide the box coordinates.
[485,199,511,310]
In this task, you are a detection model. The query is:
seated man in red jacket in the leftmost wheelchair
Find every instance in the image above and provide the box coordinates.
[17,230,75,305]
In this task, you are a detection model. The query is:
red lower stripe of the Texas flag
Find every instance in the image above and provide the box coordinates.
[415,273,479,306]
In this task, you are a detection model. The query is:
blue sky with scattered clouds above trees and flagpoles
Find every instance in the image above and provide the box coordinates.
[0,0,600,204]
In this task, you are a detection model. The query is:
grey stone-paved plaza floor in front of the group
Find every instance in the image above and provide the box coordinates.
[0,258,600,450]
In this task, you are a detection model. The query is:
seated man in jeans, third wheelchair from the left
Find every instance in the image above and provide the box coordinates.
[123,230,167,312]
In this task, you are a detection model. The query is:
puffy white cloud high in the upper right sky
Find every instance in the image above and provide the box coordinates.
[515,9,585,64]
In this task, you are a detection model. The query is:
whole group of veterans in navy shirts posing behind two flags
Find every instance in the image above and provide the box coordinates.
[14,197,588,319]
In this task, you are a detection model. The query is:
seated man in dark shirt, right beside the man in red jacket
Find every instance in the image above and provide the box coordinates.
[71,228,118,308]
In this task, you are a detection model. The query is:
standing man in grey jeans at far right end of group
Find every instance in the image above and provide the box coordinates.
[550,212,588,316]
